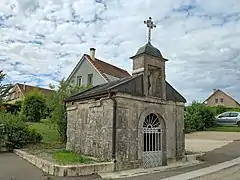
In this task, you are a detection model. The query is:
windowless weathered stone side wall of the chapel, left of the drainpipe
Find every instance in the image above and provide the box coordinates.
[66,99,113,161]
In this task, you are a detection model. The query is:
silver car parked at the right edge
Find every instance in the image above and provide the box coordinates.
[216,112,240,127]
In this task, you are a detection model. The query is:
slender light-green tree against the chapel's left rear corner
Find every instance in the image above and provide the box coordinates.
[48,79,91,143]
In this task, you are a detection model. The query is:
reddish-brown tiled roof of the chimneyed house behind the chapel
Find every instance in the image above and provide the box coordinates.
[84,54,131,81]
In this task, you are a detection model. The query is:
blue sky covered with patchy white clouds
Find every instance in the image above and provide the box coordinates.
[0,0,240,101]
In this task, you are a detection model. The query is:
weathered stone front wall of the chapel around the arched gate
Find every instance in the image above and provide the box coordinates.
[116,95,185,169]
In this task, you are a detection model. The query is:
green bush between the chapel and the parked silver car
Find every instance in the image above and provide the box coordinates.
[184,102,216,133]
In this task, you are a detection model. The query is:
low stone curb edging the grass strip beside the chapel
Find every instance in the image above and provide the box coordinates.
[14,149,114,176]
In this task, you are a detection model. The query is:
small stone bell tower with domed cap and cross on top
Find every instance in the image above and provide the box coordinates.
[131,17,167,99]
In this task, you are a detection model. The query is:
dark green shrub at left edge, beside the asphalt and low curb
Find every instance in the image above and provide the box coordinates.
[0,112,42,151]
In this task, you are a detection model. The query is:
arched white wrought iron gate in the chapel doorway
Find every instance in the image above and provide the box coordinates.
[143,113,162,168]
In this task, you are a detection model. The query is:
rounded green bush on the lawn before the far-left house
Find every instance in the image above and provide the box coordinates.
[22,89,47,122]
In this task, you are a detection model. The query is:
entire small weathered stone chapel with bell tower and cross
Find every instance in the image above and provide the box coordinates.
[65,18,186,170]
